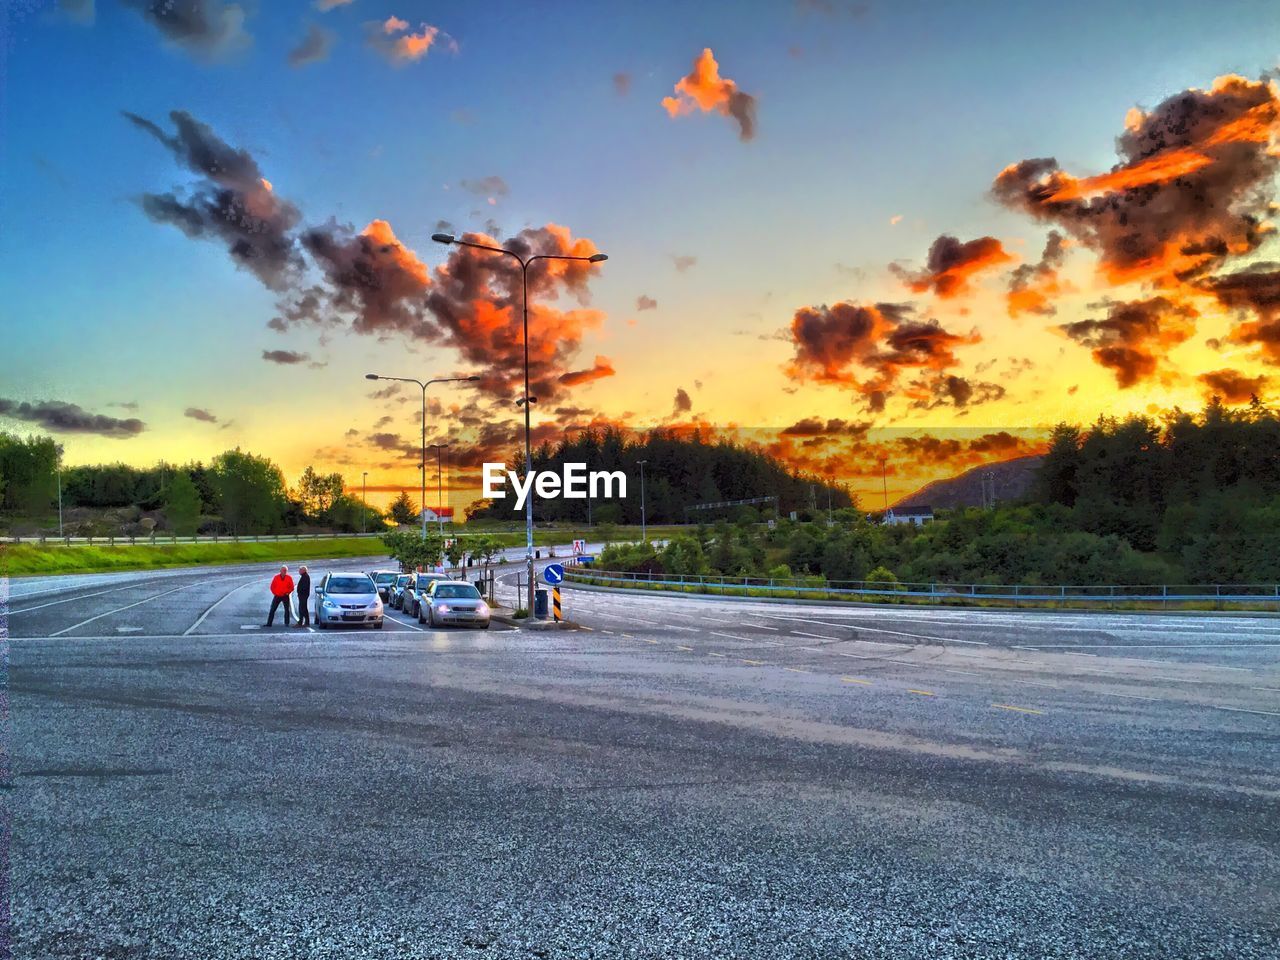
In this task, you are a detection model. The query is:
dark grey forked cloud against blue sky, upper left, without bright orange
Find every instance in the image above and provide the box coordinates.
[124,110,302,289]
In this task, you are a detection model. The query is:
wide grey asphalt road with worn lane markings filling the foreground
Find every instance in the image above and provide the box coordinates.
[6,561,1280,960]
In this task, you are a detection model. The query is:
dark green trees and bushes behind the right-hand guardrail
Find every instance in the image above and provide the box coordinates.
[599,402,1280,585]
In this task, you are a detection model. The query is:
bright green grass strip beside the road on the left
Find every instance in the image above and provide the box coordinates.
[0,538,387,576]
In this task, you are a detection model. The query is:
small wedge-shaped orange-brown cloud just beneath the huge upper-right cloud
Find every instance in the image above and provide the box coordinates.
[1059,297,1197,387]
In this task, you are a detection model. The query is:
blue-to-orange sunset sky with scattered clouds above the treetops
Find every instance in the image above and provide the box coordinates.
[0,0,1280,512]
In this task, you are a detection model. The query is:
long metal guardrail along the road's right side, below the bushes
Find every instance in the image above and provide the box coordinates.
[566,567,1280,609]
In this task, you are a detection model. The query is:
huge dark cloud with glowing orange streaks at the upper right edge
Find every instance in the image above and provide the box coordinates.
[992,77,1280,284]
